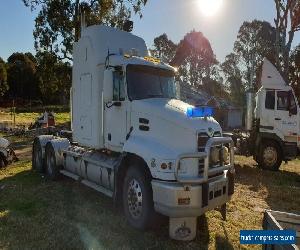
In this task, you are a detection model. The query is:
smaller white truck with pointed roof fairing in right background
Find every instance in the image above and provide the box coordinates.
[233,59,300,170]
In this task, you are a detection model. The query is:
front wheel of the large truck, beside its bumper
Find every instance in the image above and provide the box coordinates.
[123,164,156,230]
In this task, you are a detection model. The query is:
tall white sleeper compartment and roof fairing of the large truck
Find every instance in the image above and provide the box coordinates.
[72,25,148,149]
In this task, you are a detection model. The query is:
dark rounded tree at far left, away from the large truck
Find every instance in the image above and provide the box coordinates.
[7,53,38,100]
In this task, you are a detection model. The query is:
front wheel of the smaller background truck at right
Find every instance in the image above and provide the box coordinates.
[258,141,282,171]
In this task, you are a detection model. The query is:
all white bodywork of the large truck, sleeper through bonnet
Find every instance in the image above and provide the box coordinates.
[72,26,221,174]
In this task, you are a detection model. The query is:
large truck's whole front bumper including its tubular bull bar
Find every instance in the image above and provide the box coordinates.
[152,138,234,218]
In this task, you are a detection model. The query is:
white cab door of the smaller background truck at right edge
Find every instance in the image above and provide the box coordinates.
[275,90,299,143]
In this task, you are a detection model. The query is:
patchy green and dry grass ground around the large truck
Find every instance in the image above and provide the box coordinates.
[0,138,300,249]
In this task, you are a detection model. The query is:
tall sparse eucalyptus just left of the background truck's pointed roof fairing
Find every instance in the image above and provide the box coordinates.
[221,20,276,106]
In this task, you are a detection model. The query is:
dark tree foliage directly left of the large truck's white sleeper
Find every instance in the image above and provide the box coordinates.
[36,52,72,104]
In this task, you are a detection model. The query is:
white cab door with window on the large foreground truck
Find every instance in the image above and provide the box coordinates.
[104,71,129,152]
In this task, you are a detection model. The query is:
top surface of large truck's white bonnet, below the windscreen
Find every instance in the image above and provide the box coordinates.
[132,98,222,135]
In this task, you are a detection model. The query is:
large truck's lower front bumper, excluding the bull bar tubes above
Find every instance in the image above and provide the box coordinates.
[152,172,234,218]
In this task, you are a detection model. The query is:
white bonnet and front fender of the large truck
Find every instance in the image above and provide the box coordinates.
[124,98,222,180]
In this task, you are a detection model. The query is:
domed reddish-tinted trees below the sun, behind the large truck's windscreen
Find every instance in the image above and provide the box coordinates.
[152,31,227,97]
